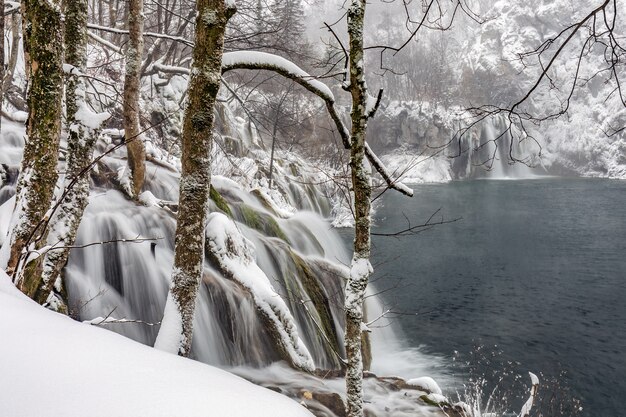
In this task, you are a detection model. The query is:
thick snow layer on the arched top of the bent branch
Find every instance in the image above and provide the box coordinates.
[222,51,335,101]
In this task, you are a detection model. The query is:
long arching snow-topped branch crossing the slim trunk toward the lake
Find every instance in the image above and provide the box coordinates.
[222,51,413,197]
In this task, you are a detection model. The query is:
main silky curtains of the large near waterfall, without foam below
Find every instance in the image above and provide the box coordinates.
[61,169,348,368]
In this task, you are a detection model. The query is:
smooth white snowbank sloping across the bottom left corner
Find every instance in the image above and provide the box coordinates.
[0,270,312,417]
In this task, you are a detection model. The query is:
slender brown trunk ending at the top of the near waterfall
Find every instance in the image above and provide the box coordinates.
[124,0,146,198]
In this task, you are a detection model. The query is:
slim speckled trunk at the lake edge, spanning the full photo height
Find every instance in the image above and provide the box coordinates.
[345,0,372,417]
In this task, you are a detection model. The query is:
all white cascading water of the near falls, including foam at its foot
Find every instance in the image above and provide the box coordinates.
[0,105,450,415]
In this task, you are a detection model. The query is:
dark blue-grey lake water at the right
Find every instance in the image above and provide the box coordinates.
[372,179,626,417]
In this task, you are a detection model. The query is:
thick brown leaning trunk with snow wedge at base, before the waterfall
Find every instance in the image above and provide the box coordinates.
[155,0,235,356]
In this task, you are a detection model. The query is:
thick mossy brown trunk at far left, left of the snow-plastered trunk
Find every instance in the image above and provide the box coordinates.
[7,0,63,290]
